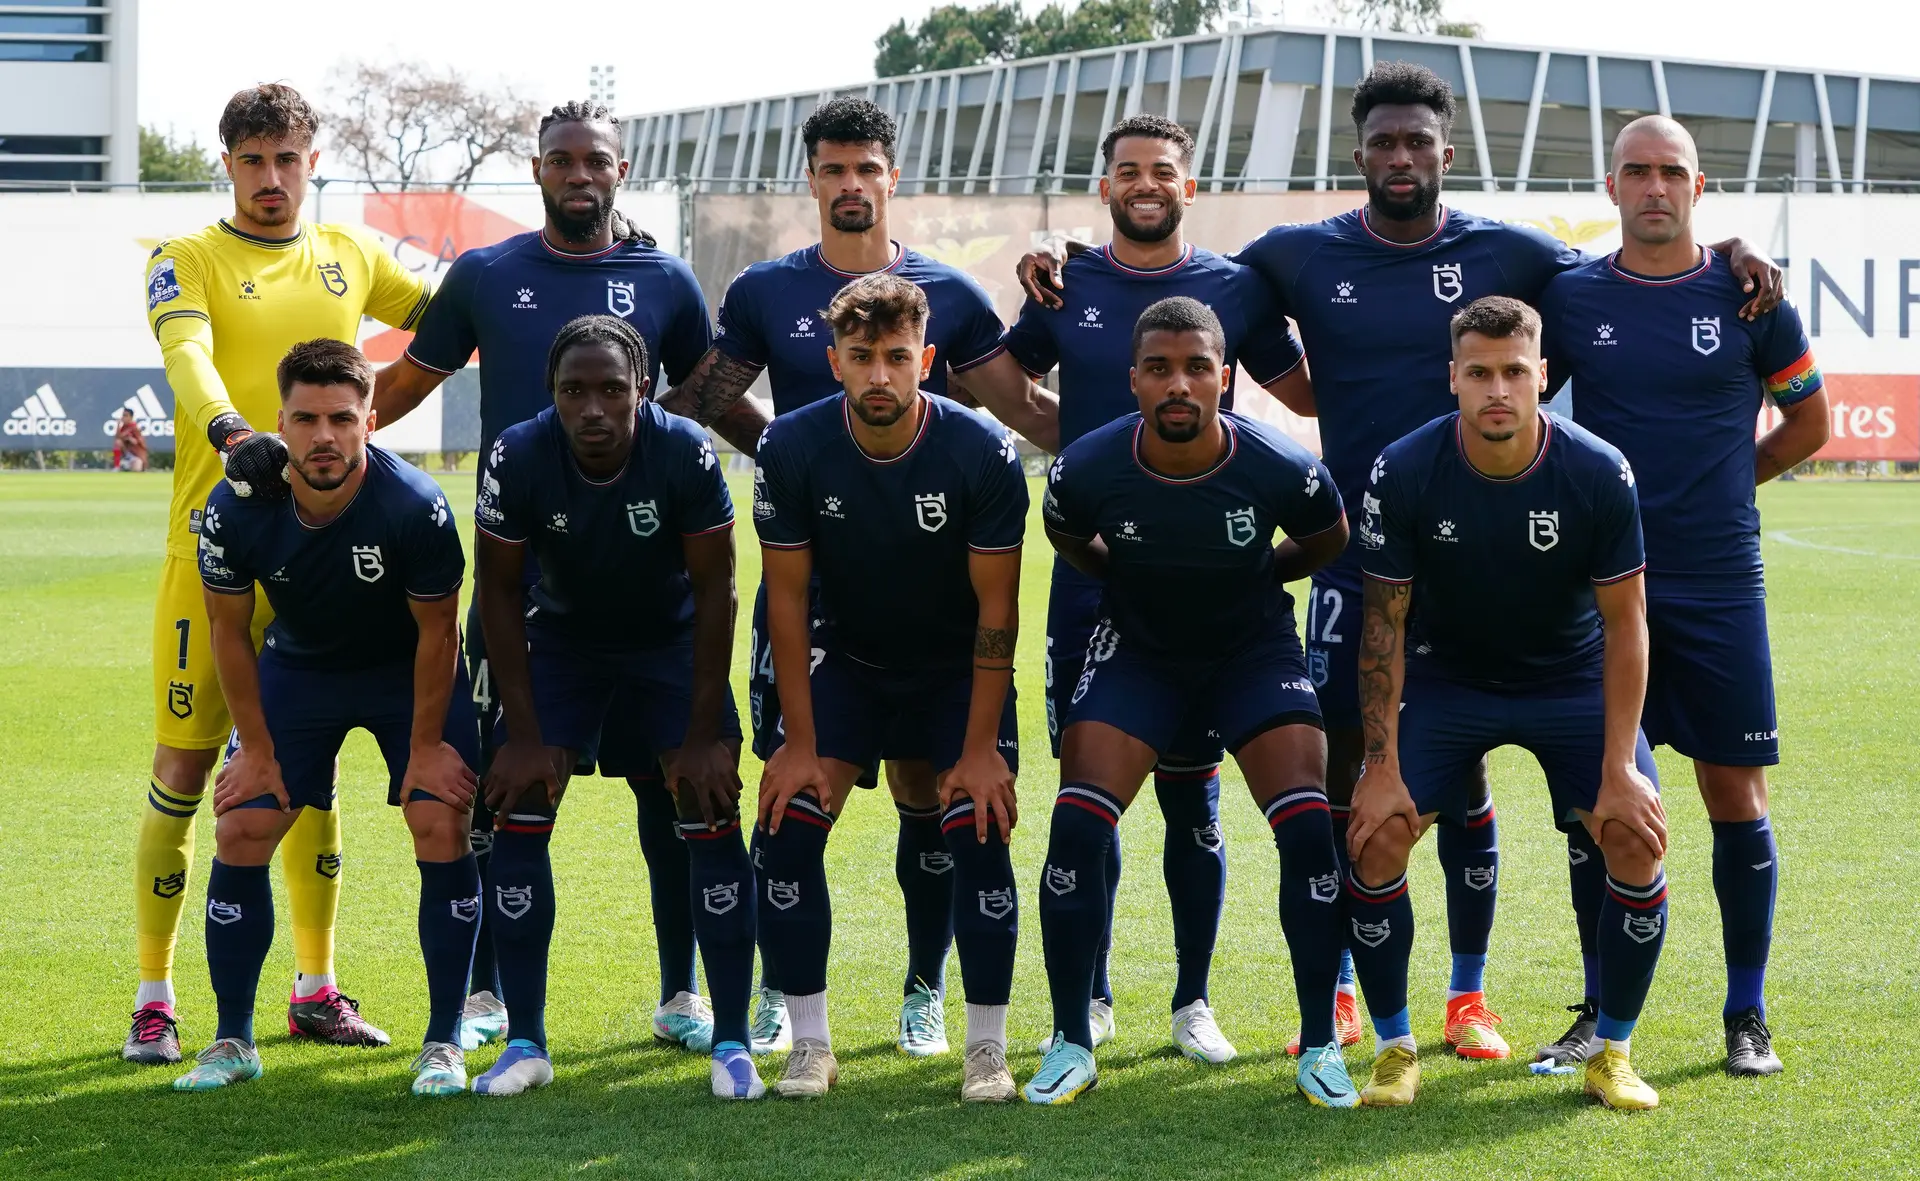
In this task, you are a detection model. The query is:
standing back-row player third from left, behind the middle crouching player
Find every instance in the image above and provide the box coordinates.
[660,98,1058,1054]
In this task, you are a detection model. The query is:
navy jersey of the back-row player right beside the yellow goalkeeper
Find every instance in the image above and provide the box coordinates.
[407,230,712,451]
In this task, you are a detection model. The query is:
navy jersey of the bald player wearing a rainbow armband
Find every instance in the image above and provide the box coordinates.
[1540,250,1820,576]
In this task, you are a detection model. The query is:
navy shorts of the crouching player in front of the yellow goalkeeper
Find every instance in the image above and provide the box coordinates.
[228,647,480,810]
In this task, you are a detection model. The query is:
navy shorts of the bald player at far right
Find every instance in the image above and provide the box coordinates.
[1640,578,1780,766]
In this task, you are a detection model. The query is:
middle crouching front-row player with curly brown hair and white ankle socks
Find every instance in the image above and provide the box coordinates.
[753,275,1029,1102]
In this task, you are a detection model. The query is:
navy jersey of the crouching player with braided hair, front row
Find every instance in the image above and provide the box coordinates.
[474,401,733,649]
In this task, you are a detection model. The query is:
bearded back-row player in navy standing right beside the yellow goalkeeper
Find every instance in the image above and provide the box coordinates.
[374,102,712,1052]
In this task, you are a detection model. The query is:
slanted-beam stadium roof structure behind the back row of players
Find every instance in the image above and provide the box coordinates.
[622,25,1920,194]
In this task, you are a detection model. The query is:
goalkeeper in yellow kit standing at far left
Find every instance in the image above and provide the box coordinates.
[121,84,428,1064]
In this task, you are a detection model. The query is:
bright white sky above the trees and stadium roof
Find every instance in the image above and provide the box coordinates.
[140,0,1920,168]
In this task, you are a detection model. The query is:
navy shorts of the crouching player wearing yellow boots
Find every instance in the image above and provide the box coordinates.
[1400,676,1661,832]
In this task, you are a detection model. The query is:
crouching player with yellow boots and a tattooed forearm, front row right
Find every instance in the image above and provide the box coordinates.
[1348,296,1667,1110]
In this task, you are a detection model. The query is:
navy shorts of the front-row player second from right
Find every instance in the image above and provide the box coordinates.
[1068,620,1321,757]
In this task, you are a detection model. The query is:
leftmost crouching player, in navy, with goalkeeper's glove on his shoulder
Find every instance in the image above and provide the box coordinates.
[173,340,480,1095]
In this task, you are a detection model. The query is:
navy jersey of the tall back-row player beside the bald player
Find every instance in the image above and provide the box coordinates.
[1233,207,1582,503]
